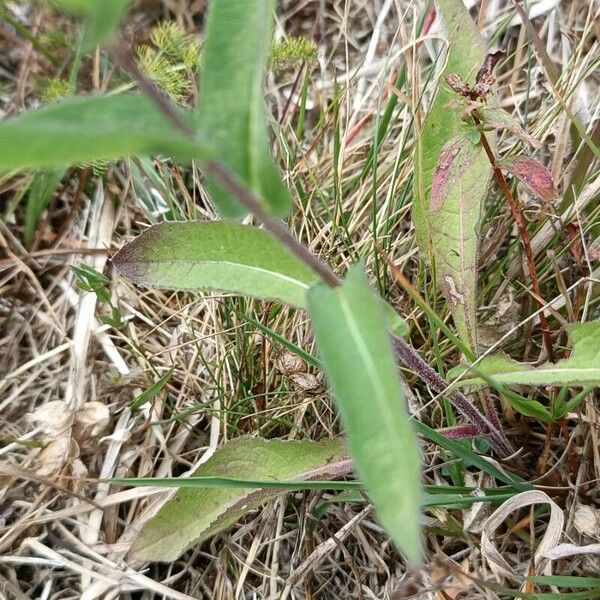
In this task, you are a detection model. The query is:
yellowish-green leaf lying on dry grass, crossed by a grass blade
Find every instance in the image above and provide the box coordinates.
[129,438,347,561]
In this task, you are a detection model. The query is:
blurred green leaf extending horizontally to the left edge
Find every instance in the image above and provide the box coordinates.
[0,94,207,170]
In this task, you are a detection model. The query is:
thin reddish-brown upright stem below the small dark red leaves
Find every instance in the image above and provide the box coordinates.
[472,113,554,362]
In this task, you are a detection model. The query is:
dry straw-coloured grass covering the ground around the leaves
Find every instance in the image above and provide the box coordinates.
[0,0,600,600]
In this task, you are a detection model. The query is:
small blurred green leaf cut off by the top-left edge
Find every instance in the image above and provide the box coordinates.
[54,0,131,50]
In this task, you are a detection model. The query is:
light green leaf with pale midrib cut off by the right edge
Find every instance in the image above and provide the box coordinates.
[448,322,600,387]
